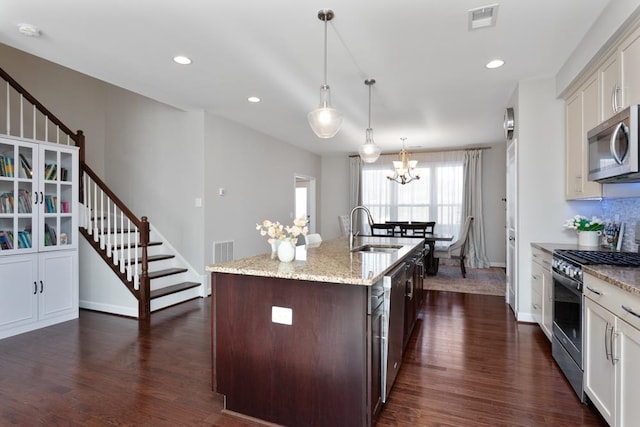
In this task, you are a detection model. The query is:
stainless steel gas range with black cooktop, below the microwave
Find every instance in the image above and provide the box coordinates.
[551,250,640,402]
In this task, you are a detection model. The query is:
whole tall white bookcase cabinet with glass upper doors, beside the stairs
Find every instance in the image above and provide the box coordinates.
[0,137,78,338]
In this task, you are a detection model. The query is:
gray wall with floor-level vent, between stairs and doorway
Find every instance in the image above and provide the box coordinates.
[204,114,322,264]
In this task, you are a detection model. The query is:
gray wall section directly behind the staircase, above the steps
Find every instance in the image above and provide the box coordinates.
[104,86,205,273]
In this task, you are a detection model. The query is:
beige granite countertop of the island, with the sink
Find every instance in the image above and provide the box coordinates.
[206,237,424,286]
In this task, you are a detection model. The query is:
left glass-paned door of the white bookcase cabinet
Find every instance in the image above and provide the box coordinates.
[0,138,38,255]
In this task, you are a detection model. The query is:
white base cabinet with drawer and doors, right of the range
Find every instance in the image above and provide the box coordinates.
[584,274,640,427]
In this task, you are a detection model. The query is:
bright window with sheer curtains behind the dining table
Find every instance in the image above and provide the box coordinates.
[362,152,463,234]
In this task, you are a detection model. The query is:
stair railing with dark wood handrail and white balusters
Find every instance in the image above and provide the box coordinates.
[0,67,151,319]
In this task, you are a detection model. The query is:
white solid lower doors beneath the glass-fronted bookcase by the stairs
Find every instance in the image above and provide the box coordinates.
[0,250,78,339]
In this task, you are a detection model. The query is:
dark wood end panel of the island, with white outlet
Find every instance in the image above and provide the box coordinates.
[212,273,372,426]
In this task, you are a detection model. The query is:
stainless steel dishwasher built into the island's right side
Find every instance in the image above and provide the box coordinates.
[381,262,406,402]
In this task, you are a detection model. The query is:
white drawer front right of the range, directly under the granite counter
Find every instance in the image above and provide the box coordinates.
[584,274,640,329]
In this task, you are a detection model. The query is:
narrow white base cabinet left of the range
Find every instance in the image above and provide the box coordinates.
[531,246,553,341]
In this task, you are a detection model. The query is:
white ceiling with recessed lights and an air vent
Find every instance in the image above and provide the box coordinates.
[0,0,609,155]
